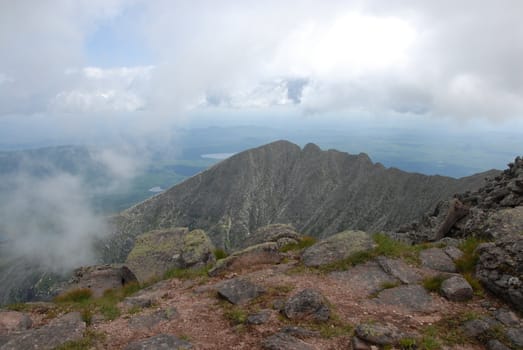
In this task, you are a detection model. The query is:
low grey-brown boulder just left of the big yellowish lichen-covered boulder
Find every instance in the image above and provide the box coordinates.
[65,264,138,297]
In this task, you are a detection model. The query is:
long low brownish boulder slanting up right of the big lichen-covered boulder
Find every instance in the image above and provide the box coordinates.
[209,242,283,277]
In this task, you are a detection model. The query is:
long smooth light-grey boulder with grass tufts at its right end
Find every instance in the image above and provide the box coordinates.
[301,231,374,267]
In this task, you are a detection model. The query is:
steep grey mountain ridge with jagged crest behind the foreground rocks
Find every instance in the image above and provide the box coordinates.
[106,141,498,260]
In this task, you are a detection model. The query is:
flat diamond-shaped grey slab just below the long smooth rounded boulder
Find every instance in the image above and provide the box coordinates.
[329,261,398,295]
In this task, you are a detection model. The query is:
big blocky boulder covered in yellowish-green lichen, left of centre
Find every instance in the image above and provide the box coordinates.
[126,228,215,282]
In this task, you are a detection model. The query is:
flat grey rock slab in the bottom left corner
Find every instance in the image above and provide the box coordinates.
[0,312,86,350]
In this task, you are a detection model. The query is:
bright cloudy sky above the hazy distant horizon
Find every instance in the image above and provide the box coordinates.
[0,0,523,152]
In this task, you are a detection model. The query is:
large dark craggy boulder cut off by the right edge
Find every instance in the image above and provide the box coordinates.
[476,235,523,311]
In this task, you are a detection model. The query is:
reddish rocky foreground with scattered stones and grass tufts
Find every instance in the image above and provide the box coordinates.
[0,232,523,350]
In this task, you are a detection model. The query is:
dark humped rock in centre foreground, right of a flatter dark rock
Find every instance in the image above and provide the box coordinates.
[284,289,330,321]
